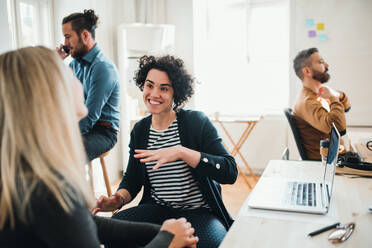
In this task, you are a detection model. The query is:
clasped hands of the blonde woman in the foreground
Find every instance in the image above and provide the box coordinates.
[160,218,199,248]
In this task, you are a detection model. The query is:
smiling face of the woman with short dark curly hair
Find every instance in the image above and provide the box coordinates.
[143,69,174,115]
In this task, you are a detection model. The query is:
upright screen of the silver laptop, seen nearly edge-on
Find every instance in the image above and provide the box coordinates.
[324,123,340,201]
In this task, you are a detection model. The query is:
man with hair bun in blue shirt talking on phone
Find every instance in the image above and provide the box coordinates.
[57,10,120,161]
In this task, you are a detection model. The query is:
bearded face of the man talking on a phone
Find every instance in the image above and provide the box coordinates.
[62,22,89,58]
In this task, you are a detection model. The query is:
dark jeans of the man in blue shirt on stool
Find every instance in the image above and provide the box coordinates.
[83,125,117,162]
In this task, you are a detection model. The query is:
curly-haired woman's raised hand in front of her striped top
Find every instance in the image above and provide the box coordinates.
[134,145,182,170]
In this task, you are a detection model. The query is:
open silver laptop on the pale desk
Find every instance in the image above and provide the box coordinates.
[248,123,340,214]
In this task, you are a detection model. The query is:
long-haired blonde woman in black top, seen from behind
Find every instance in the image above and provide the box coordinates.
[0,47,198,247]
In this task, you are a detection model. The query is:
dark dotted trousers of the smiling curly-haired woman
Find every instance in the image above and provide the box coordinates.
[112,203,227,248]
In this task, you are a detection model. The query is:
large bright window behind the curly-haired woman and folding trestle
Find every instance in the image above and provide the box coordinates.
[195,0,289,115]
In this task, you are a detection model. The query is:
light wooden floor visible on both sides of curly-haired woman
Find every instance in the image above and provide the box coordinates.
[100,173,254,218]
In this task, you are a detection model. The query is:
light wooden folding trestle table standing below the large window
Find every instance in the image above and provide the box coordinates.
[212,114,262,189]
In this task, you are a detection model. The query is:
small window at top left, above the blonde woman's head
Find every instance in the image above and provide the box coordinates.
[10,0,53,47]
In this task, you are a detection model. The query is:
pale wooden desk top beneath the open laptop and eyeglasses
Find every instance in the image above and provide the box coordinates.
[220,160,372,248]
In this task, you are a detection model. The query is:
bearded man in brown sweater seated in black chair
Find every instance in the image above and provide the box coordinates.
[293,48,350,160]
